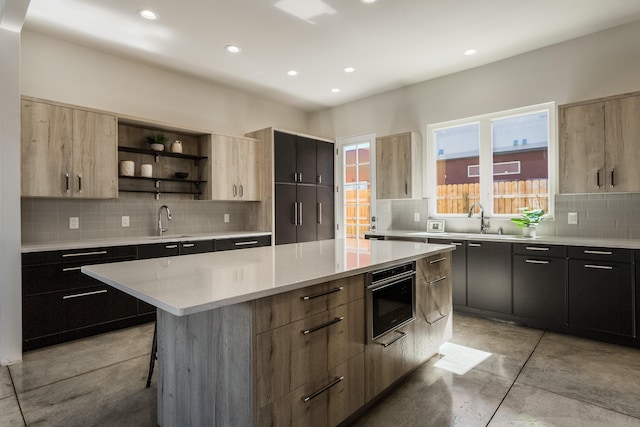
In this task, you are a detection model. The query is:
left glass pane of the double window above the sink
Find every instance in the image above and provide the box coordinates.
[435,123,480,214]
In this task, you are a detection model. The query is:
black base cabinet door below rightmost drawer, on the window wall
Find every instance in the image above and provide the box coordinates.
[569,259,634,336]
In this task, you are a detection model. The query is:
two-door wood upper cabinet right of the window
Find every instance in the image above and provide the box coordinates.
[559,94,640,193]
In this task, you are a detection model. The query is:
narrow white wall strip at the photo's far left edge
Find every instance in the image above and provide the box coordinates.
[0,25,22,365]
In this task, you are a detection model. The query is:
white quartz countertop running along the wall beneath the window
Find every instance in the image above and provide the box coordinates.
[365,230,640,249]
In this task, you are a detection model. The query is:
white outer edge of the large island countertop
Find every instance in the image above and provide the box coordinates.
[81,243,456,316]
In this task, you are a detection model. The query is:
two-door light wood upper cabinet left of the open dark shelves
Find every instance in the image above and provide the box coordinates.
[21,100,117,198]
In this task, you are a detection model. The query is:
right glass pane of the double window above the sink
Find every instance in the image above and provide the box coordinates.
[491,111,549,214]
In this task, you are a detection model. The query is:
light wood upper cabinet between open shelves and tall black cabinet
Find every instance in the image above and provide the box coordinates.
[209,134,261,201]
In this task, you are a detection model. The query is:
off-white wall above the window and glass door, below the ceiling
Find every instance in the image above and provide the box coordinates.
[309,21,640,141]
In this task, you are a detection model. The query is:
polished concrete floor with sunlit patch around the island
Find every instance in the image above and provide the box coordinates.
[0,313,640,427]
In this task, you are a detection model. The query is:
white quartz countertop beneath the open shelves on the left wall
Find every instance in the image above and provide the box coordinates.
[22,231,271,253]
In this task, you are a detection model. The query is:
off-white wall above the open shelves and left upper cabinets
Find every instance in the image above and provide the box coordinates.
[21,31,308,135]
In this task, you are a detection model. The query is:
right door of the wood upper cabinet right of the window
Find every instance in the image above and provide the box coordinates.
[604,95,640,192]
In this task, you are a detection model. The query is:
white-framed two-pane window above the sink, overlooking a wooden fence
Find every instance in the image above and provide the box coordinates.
[427,103,556,217]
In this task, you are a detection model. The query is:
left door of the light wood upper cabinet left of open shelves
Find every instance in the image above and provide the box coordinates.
[21,100,73,197]
